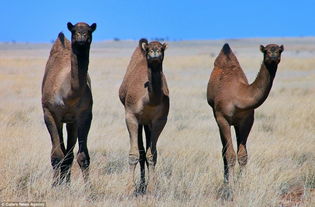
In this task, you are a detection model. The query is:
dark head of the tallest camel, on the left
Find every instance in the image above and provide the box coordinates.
[67,22,96,47]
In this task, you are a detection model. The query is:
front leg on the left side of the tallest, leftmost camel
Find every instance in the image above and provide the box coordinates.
[44,108,65,186]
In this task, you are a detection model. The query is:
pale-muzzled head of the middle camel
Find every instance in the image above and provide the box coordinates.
[139,39,167,64]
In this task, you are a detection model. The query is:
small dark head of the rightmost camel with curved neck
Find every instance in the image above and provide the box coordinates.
[260,44,283,65]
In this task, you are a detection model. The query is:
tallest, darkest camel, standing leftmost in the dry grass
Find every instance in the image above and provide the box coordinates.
[42,22,96,186]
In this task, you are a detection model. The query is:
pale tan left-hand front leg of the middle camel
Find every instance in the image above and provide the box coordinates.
[126,112,140,195]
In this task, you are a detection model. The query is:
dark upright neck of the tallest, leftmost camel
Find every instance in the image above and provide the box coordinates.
[71,47,89,94]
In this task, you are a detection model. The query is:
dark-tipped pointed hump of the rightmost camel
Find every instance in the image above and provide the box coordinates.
[214,43,240,69]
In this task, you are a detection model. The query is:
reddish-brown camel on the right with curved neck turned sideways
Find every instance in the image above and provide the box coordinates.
[207,44,283,183]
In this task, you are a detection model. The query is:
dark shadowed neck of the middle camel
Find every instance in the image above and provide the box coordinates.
[148,63,163,105]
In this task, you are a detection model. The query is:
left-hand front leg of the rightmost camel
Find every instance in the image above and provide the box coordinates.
[215,114,236,183]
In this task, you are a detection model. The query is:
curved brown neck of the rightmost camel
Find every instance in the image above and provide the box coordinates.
[248,62,278,108]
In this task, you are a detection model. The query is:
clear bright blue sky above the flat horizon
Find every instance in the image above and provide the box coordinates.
[0,0,315,43]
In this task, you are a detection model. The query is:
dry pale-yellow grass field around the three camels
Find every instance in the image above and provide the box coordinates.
[0,38,315,207]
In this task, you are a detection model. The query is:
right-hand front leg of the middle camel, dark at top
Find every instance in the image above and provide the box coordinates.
[146,118,167,194]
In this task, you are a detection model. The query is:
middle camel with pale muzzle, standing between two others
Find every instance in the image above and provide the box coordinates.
[119,39,169,194]
